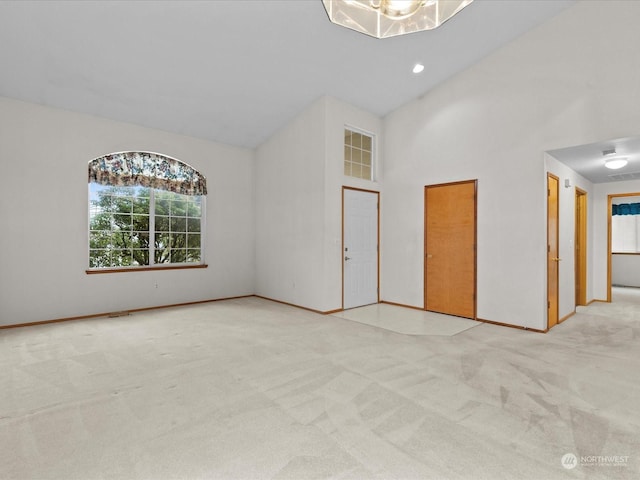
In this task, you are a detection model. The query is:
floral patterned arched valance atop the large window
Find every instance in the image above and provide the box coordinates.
[89,152,207,195]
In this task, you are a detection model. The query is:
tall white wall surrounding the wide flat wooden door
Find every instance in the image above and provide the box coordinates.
[382,1,640,329]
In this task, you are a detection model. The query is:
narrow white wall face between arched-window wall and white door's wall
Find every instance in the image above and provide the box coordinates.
[255,99,326,310]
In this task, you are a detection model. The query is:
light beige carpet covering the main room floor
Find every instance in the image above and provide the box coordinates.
[0,298,640,480]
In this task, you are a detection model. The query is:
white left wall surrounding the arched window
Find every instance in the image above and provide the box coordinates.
[0,98,255,325]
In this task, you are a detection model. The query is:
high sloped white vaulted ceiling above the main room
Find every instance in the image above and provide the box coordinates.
[0,0,574,148]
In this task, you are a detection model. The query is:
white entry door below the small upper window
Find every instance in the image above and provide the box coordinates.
[342,188,379,309]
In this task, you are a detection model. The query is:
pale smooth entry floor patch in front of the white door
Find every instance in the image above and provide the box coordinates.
[333,303,479,336]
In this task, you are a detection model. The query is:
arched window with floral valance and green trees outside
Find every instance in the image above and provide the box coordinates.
[89,152,207,270]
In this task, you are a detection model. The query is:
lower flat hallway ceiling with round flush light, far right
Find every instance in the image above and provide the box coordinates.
[547,137,640,183]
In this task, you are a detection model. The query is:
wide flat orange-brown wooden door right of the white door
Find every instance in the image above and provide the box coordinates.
[424,180,477,319]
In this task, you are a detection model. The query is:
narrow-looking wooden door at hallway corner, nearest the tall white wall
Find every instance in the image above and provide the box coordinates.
[547,173,560,328]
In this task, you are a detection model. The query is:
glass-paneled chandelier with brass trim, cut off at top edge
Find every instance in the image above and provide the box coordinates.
[322,0,473,38]
